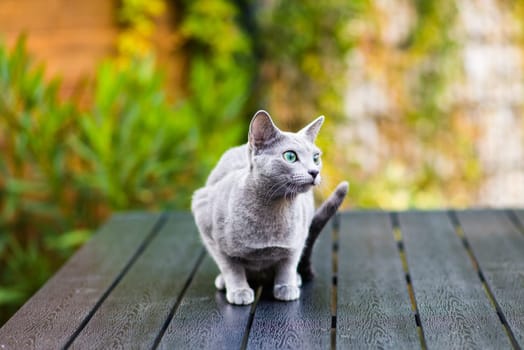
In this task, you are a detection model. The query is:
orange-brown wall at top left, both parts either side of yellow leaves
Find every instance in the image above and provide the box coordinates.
[0,0,187,98]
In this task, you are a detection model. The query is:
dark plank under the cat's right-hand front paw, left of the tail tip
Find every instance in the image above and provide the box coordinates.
[247,219,332,349]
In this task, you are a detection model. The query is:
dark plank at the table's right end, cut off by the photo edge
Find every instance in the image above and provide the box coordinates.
[457,210,524,348]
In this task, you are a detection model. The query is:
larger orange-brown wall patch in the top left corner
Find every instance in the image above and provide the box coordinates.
[0,0,118,95]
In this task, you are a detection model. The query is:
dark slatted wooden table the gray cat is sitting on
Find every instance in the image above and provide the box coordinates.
[0,210,524,350]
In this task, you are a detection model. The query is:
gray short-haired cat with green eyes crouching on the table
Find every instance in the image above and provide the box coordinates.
[191,111,348,305]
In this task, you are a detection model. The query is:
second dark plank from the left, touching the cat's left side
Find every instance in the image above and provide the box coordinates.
[68,213,203,349]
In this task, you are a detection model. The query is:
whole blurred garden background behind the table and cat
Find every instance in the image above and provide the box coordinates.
[0,0,524,325]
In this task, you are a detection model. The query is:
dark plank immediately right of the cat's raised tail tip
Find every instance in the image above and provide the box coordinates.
[336,212,420,349]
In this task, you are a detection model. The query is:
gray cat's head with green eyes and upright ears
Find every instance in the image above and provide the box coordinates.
[248,110,324,198]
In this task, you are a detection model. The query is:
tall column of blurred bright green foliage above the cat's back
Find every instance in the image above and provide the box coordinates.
[180,0,254,171]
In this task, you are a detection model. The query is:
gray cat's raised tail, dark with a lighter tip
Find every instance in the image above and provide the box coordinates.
[298,181,349,281]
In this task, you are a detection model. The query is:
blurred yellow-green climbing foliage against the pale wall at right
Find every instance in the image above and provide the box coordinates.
[326,0,480,209]
